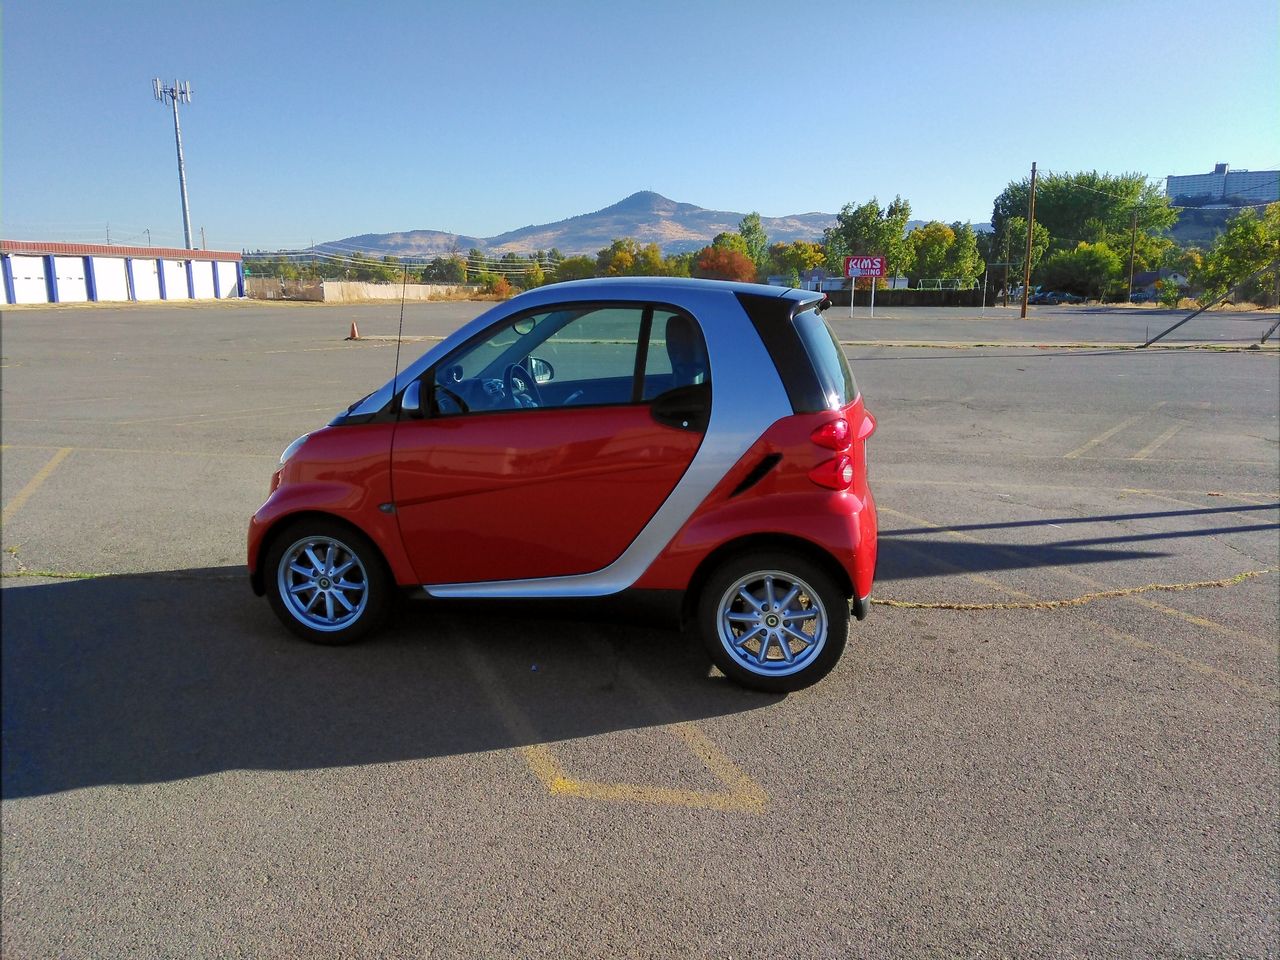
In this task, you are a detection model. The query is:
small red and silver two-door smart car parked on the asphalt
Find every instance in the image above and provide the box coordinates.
[248,278,876,691]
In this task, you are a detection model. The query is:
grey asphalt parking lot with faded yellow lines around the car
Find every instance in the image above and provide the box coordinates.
[0,303,1280,957]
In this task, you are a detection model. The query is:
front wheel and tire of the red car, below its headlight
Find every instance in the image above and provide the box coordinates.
[262,518,393,646]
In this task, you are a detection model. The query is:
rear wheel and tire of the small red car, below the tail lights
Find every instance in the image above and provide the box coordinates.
[698,552,850,692]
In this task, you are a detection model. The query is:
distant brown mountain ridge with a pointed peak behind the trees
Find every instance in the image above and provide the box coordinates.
[316,191,836,257]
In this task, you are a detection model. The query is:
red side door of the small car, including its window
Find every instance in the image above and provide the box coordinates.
[392,303,710,584]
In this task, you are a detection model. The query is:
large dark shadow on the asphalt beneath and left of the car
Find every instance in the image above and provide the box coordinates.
[0,567,780,799]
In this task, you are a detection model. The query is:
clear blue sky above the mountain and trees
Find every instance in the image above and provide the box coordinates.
[0,0,1280,248]
